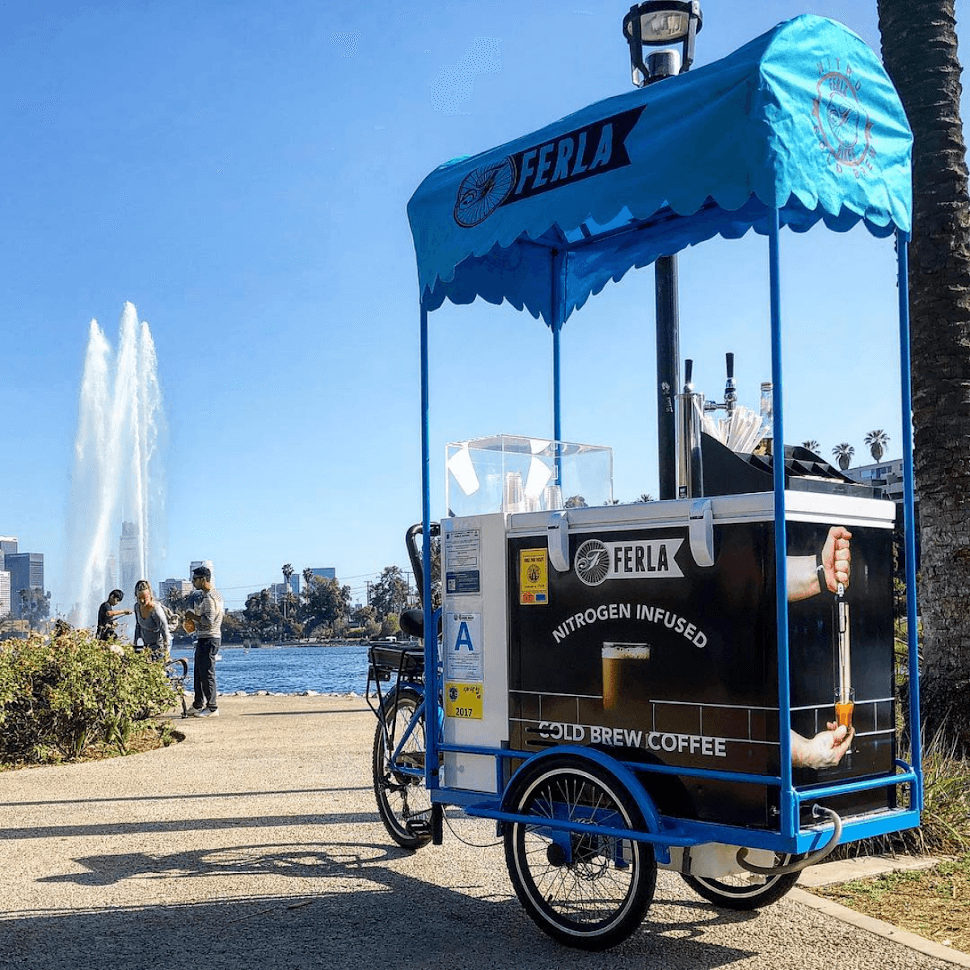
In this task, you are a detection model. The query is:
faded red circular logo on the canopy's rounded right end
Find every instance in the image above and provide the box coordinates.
[812,61,876,178]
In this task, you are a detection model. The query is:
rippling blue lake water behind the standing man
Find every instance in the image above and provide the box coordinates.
[172,644,367,694]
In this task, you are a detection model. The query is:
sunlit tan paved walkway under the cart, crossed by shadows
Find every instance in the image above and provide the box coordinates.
[0,697,968,970]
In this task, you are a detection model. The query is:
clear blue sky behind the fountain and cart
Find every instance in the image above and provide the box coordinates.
[0,0,966,609]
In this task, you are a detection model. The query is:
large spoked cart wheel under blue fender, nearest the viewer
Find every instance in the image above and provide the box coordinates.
[505,757,657,950]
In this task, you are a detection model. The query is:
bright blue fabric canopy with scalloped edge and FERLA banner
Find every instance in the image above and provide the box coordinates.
[408,15,912,325]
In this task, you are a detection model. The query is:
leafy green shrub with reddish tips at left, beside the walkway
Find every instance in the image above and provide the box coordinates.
[0,630,176,764]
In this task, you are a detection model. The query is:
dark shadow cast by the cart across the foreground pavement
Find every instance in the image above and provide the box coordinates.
[0,843,752,970]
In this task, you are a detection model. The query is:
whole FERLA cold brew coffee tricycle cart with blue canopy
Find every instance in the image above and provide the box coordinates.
[368,16,922,949]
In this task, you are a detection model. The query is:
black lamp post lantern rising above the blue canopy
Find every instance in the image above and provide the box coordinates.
[623,0,703,88]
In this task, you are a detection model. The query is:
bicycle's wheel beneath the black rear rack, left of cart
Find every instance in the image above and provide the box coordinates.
[374,690,431,849]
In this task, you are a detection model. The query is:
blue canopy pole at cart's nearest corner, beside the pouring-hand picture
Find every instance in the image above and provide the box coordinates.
[768,209,799,837]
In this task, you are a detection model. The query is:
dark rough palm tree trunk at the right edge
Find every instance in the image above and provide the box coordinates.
[878,0,970,753]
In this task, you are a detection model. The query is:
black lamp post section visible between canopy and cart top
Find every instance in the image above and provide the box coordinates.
[654,256,680,500]
